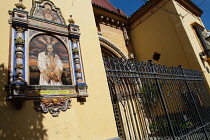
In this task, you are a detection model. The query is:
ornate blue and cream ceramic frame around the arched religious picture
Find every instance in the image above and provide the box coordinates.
[6,0,88,116]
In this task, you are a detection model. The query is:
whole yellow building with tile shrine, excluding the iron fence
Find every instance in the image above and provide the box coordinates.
[0,0,210,140]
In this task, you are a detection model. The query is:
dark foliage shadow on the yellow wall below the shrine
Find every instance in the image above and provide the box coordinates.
[0,64,47,140]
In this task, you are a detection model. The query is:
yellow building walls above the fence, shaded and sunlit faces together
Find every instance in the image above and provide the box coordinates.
[131,0,210,88]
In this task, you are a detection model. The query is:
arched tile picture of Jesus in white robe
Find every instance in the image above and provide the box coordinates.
[29,35,72,85]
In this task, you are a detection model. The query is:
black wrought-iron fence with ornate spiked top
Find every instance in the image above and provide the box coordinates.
[103,57,210,140]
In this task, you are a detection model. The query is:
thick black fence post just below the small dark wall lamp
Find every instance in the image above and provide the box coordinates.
[149,60,176,140]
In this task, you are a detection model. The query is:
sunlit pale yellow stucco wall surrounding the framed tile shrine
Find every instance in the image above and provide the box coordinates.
[0,0,117,140]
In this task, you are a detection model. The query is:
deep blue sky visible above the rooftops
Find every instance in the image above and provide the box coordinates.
[109,0,210,31]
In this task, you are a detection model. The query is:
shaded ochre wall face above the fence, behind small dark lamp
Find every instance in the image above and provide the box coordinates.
[131,2,190,67]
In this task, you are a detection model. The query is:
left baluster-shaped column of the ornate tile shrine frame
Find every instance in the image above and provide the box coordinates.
[9,0,28,98]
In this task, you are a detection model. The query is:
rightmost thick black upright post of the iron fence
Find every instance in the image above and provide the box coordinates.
[179,65,209,140]
